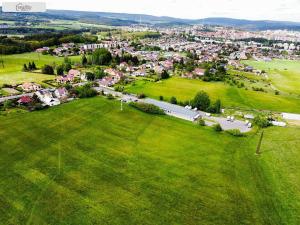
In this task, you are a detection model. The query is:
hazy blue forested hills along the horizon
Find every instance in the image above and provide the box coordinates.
[0,8,300,30]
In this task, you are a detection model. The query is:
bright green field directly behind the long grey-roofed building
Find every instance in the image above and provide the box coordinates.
[126,77,300,113]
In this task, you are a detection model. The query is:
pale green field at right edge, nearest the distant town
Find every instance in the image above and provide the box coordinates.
[244,60,300,95]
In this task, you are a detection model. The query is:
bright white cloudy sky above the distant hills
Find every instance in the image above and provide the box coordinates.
[1,0,300,22]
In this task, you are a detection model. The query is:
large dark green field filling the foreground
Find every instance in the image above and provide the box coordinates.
[0,97,300,225]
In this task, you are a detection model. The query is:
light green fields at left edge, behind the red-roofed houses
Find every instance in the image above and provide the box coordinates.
[0,53,78,85]
